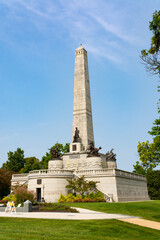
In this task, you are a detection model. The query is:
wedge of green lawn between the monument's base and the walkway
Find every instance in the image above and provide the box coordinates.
[62,201,160,222]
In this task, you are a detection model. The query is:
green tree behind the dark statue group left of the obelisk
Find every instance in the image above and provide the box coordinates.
[40,143,69,169]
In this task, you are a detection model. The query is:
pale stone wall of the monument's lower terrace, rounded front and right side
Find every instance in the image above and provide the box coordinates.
[12,168,149,202]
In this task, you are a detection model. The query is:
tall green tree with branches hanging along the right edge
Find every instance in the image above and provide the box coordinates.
[133,11,160,174]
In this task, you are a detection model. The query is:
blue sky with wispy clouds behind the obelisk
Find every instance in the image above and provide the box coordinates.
[0,0,160,171]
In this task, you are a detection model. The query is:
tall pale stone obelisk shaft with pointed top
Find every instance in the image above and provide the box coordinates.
[72,45,94,150]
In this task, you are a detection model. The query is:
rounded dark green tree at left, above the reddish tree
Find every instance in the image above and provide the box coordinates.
[2,148,25,173]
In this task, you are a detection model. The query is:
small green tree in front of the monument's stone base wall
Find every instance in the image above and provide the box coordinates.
[66,176,98,197]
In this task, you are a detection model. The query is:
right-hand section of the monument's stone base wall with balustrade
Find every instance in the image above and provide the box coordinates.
[76,169,150,202]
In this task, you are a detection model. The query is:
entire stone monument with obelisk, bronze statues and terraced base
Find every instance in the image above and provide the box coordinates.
[11,45,149,202]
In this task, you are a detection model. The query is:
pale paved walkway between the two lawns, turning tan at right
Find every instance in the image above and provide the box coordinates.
[0,208,160,230]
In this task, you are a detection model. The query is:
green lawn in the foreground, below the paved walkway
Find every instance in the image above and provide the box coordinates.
[0,217,160,240]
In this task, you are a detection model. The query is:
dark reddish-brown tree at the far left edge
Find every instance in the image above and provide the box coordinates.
[0,168,13,199]
